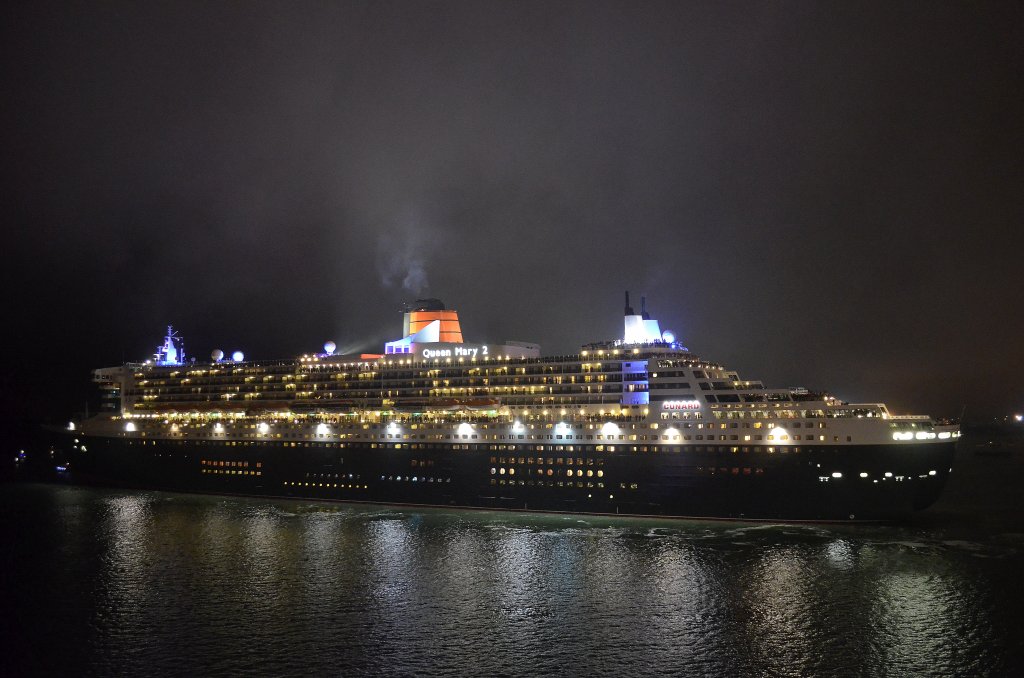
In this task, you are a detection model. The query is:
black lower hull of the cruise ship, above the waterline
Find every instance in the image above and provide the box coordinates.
[56,433,954,521]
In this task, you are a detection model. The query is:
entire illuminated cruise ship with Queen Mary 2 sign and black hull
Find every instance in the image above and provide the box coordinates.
[67,294,959,520]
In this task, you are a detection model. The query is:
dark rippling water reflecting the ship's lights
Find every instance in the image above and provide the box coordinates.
[0,453,1024,676]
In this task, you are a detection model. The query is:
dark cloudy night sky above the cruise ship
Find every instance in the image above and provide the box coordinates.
[0,0,1024,436]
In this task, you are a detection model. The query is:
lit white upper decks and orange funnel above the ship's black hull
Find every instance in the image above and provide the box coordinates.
[83,300,954,441]
